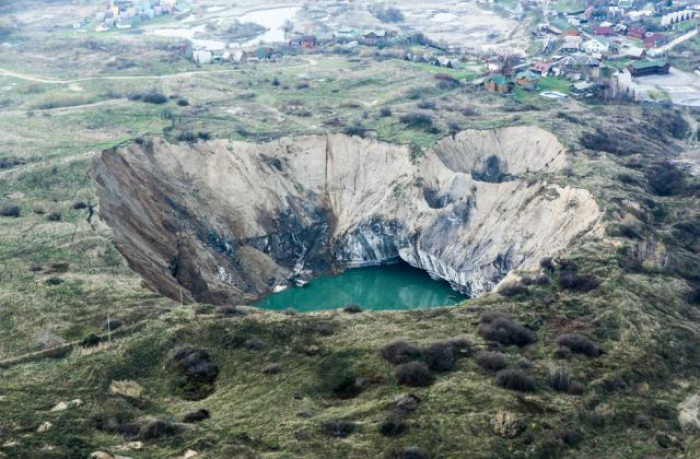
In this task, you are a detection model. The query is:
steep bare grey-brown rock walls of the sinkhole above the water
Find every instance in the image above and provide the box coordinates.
[92,127,600,304]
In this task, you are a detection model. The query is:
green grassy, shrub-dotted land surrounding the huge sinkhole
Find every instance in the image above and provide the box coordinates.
[0,24,700,458]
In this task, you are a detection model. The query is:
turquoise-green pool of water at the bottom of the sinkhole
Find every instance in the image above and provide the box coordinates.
[255,264,467,312]
